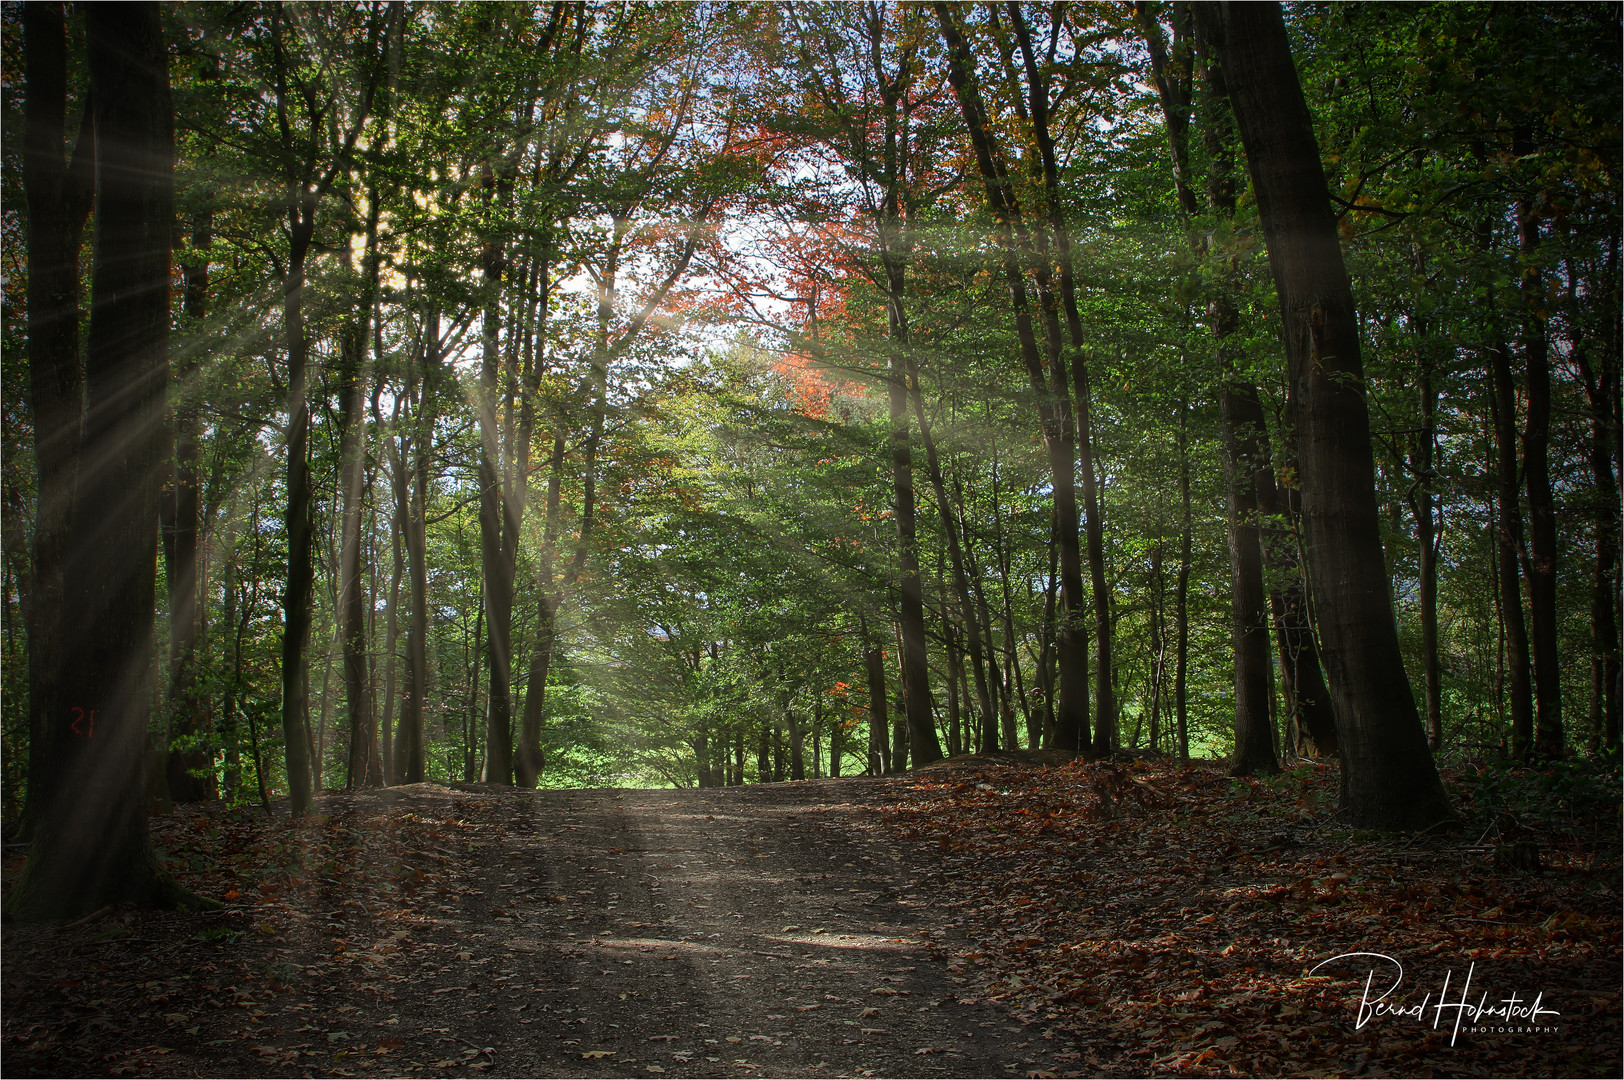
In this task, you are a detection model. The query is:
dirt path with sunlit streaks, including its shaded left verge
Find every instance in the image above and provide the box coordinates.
[5,780,1062,1077]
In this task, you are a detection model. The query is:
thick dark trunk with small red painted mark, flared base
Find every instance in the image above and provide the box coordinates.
[6,3,198,919]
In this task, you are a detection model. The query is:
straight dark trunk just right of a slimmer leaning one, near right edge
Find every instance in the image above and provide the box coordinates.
[1512,189,1562,760]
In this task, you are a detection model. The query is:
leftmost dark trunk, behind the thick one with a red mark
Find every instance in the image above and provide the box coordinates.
[19,3,96,838]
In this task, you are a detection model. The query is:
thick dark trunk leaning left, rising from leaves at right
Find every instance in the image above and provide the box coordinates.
[1195,3,1453,828]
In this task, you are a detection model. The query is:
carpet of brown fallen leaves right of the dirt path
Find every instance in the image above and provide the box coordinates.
[864,762,1621,1077]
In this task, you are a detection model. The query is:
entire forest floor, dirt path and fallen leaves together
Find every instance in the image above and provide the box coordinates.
[0,755,1624,1078]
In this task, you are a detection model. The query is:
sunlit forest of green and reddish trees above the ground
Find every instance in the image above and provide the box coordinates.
[0,0,1624,1075]
